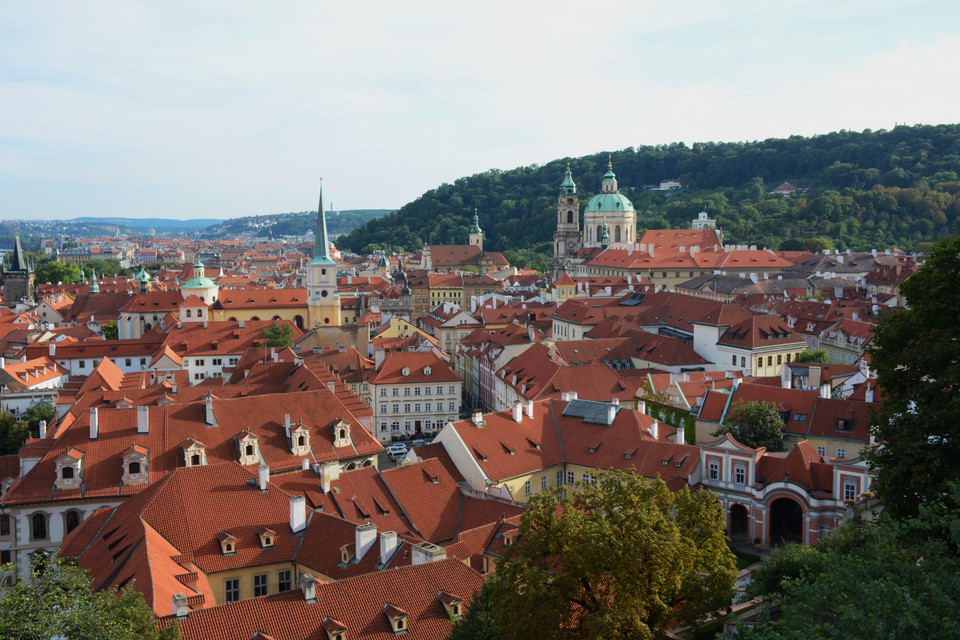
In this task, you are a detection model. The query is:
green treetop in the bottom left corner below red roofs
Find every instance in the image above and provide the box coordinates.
[0,556,180,640]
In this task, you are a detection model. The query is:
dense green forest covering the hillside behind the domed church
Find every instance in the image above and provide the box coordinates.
[338,124,960,256]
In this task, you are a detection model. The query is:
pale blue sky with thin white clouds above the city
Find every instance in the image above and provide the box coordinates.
[0,0,960,220]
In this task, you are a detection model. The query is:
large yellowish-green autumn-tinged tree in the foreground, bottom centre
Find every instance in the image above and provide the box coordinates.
[488,470,736,640]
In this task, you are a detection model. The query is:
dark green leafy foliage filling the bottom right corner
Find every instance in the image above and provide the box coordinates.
[740,483,960,640]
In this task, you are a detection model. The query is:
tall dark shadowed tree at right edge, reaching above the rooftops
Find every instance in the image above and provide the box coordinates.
[869,235,960,515]
